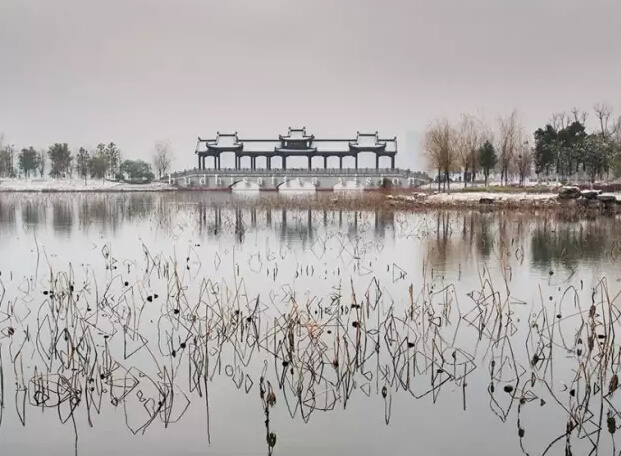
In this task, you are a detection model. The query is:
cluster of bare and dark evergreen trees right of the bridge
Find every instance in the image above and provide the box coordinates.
[422,104,621,190]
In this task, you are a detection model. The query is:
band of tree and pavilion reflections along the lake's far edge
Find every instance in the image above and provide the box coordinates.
[0,193,621,269]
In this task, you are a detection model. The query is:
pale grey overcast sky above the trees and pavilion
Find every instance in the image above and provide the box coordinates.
[0,0,621,169]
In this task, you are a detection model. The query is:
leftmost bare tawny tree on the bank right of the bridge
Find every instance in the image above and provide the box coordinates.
[424,119,458,190]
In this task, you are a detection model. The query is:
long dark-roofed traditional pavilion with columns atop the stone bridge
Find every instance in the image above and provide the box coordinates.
[195,128,397,170]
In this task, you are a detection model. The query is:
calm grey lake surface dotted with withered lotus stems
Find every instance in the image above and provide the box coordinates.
[0,193,621,456]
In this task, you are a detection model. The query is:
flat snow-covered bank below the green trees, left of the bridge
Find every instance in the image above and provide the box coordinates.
[0,179,175,192]
